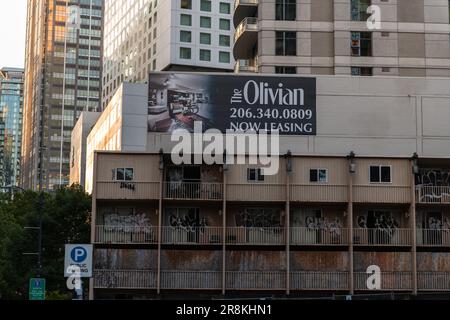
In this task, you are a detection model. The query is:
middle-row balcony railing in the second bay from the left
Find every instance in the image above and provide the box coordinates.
[162,226,223,245]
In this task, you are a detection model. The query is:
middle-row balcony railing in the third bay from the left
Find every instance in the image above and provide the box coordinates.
[226,227,286,245]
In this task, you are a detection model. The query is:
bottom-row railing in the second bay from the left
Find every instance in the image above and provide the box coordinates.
[161,271,222,290]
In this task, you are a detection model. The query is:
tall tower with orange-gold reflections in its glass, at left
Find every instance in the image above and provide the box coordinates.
[21,0,103,190]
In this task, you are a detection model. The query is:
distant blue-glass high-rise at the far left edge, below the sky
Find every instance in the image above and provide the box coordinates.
[0,68,23,187]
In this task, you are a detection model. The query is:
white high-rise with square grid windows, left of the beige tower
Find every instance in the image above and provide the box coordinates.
[102,0,234,109]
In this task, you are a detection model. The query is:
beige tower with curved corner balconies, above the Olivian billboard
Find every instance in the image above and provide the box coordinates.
[233,0,450,77]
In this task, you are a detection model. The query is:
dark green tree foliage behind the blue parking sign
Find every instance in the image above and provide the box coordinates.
[0,186,91,300]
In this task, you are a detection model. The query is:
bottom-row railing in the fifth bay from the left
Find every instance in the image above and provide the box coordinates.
[355,271,412,291]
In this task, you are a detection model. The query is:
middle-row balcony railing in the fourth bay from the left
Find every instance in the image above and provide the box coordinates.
[291,227,349,245]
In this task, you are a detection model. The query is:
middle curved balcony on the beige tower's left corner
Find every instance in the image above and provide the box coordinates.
[233,18,258,60]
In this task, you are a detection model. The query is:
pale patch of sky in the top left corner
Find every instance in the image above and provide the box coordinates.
[0,0,27,68]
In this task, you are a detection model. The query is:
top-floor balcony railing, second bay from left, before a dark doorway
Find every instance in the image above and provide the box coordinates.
[164,182,223,200]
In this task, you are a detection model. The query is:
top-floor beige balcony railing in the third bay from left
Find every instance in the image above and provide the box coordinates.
[227,183,287,202]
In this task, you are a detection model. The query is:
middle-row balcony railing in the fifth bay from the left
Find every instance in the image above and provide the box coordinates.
[353,228,412,246]
